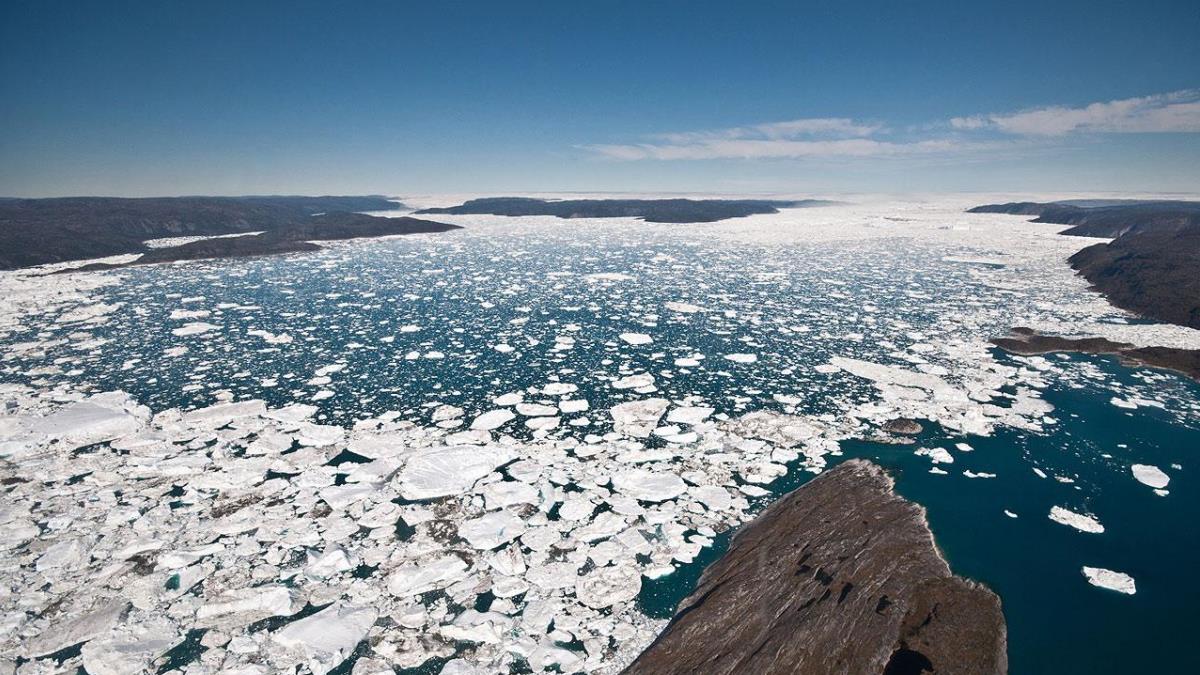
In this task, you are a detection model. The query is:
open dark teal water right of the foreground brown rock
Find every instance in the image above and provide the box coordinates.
[638,348,1200,675]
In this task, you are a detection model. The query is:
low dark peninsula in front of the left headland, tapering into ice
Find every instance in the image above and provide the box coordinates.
[56,213,461,273]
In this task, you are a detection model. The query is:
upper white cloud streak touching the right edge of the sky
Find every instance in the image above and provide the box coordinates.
[950,89,1200,136]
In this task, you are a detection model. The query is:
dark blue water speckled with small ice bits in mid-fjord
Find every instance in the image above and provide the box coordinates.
[13,238,979,425]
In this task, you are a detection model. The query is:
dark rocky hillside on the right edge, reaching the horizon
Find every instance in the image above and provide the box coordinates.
[971,202,1200,328]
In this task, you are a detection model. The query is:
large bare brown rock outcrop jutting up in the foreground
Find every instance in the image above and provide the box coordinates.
[625,460,1008,675]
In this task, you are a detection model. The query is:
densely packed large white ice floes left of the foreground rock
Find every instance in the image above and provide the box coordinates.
[0,388,868,673]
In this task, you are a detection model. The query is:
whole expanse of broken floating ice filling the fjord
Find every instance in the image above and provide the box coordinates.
[0,193,1200,671]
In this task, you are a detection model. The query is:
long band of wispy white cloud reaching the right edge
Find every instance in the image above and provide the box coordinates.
[581,90,1200,161]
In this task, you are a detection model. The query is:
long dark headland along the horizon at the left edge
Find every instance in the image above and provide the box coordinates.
[0,197,402,269]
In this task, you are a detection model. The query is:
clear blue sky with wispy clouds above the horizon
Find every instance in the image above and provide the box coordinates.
[0,0,1200,196]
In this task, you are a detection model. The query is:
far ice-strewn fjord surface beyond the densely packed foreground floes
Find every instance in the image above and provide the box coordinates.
[0,197,1200,427]
